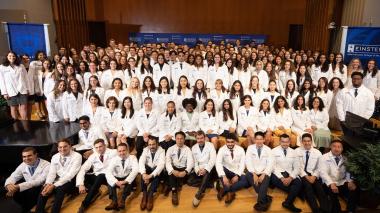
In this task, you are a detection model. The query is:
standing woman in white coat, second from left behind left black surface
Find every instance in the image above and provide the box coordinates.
[62,78,83,122]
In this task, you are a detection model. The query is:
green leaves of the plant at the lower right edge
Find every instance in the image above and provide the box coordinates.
[346,144,380,191]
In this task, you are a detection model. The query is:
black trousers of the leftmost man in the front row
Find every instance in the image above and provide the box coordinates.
[13,186,42,212]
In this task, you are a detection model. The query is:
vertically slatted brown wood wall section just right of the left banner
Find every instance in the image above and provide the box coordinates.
[52,0,89,50]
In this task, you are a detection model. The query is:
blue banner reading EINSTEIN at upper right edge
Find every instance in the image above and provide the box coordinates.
[344,27,380,64]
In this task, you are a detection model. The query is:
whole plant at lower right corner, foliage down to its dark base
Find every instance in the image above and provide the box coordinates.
[346,143,380,208]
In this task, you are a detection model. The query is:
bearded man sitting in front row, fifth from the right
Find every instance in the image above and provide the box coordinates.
[215,134,247,204]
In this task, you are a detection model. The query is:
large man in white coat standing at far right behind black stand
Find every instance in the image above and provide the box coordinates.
[336,72,375,121]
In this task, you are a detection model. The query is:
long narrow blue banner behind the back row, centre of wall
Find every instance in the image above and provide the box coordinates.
[129,33,267,46]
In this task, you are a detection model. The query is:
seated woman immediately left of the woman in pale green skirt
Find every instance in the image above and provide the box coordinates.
[291,95,315,147]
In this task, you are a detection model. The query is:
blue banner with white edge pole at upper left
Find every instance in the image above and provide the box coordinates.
[4,23,51,59]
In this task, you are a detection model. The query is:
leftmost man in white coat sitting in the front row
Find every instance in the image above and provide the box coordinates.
[4,147,50,212]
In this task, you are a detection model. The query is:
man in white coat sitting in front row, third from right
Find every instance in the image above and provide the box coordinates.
[271,134,302,212]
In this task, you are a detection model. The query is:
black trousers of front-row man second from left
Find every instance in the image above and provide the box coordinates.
[36,178,76,213]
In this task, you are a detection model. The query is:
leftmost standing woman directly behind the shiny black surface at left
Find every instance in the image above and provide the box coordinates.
[46,80,66,122]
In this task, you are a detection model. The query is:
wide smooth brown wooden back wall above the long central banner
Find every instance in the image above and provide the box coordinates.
[86,0,307,45]
